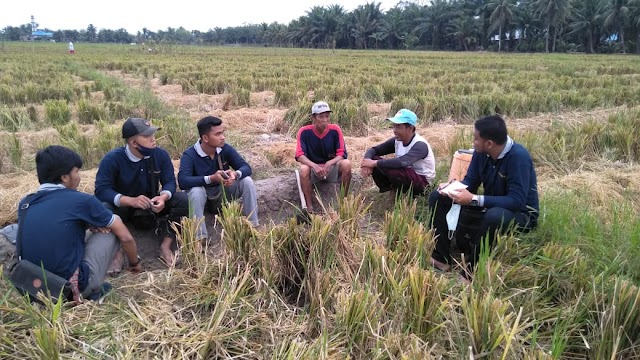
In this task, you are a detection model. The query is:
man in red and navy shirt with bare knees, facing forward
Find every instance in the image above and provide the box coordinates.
[296,101,351,212]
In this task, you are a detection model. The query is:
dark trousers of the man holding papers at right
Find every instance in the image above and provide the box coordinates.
[429,190,537,271]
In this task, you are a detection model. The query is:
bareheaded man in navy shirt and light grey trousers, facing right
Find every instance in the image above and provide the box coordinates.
[178,116,258,240]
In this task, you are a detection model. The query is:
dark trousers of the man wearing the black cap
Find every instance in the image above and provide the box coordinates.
[104,191,189,240]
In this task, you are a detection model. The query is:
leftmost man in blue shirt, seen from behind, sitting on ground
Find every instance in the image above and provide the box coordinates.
[19,146,141,301]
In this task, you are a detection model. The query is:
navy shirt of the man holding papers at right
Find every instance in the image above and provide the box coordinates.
[462,143,540,218]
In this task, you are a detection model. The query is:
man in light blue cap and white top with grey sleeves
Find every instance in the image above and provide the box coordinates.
[360,109,436,198]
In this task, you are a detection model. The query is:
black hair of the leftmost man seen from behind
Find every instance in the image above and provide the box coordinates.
[36,145,82,184]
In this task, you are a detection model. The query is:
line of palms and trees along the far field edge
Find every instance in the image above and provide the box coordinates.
[2,0,640,54]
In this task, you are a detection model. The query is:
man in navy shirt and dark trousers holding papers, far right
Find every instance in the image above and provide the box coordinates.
[429,115,539,280]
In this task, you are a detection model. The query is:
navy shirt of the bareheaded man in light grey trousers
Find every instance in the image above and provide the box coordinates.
[178,144,251,190]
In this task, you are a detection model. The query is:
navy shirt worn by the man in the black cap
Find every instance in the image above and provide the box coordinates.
[95,147,176,205]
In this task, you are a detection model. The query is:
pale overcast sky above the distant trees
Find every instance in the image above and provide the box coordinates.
[0,0,399,34]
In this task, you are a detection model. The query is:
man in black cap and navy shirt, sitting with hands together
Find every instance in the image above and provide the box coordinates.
[95,118,189,265]
